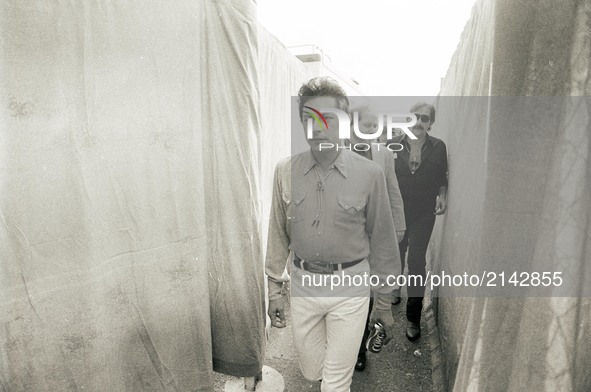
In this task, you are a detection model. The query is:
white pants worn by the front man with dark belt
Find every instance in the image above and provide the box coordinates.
[291,262,369,392]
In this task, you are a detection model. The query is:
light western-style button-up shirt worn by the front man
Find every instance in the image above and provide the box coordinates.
[265,150,400,300]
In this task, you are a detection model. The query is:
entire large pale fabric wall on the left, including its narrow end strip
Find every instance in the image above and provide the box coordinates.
[0,0,278,392]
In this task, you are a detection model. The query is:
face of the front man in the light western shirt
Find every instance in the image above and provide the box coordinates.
[302,97,339,151]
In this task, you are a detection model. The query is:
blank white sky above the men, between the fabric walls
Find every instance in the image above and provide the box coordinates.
[257,0,475,96]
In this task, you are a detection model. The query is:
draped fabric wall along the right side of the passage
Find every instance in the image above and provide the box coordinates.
[433,0,591,391]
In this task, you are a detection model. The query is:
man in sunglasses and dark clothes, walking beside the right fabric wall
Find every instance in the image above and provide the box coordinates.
[392,102,447,341]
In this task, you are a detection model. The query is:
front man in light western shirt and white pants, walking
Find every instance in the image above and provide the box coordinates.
[266,78,400,392]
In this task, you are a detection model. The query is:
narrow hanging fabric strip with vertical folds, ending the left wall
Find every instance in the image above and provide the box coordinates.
[199,1,265,376]
